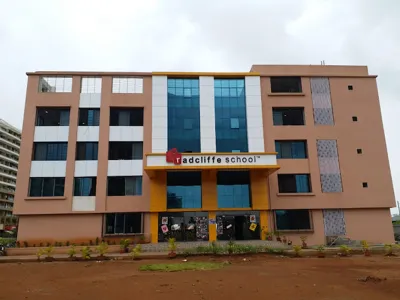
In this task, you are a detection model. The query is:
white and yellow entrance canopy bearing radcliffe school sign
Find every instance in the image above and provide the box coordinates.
[144,149,279,177]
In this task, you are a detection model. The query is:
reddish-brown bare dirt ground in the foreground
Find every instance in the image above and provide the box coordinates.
[0,256,400,300]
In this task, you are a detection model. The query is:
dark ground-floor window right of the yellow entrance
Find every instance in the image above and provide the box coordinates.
[275,209,312,231]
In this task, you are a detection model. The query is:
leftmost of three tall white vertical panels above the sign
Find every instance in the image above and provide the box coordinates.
[152,76,168,153]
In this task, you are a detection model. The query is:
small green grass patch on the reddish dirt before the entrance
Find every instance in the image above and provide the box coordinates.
[139,262,225,272]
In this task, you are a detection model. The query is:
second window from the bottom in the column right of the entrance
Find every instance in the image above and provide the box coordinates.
[278,174,311,193]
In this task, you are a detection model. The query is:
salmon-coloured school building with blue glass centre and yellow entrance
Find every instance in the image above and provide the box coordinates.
[15,65,395,244]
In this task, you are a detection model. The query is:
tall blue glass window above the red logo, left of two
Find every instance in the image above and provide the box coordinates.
[168,78,200,152]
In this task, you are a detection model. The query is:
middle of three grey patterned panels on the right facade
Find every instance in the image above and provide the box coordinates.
[317,140,343,193]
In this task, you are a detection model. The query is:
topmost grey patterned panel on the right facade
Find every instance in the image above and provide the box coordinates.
[310,78,334,125]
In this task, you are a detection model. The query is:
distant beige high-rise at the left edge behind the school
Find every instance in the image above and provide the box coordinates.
[0,119,21,225]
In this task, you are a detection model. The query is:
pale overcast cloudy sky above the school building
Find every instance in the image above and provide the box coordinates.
[0,0,400,213]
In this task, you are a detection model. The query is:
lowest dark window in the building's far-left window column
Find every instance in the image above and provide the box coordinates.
[29,177,65,197]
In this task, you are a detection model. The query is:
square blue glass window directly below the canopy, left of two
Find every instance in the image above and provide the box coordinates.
[167,172,201,209]
